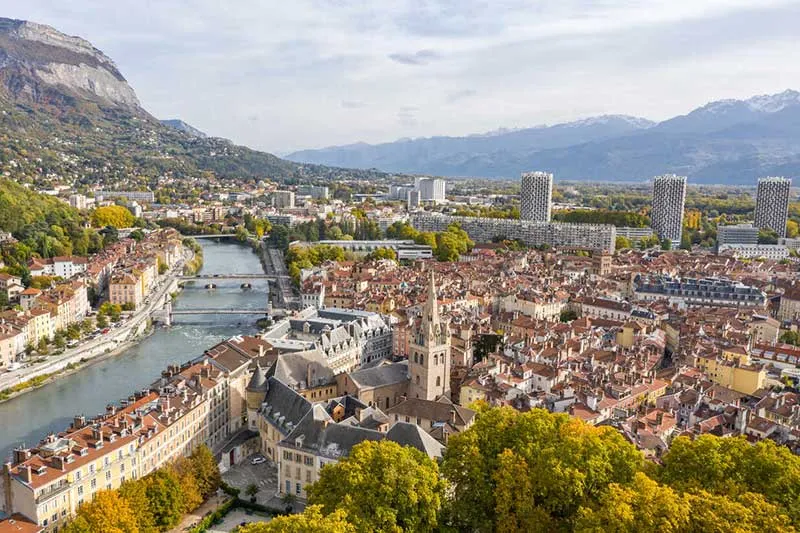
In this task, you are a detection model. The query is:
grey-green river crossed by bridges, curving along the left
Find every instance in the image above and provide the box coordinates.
[0,239,268,458]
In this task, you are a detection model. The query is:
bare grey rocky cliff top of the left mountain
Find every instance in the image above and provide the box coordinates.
[0,18,140,110]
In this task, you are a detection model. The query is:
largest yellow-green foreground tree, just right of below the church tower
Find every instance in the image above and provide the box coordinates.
[442,407,643,531]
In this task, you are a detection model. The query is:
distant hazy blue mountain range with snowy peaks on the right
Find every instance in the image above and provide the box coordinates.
[287,90,800,184]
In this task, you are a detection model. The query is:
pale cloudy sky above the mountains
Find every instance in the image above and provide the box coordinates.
[0,0,800,154]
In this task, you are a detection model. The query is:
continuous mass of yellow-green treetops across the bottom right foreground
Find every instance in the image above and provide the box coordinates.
[276,406,800,533]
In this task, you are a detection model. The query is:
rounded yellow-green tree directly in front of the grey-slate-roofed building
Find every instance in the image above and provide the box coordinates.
[307,441,445,532]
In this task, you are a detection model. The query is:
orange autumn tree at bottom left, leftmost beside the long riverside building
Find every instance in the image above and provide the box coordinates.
[64,490,139,533]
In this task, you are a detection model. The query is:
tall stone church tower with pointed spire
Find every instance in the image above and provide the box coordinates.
[408,270,450,400]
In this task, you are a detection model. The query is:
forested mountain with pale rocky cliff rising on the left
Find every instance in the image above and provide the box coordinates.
[0,18,384,189]
